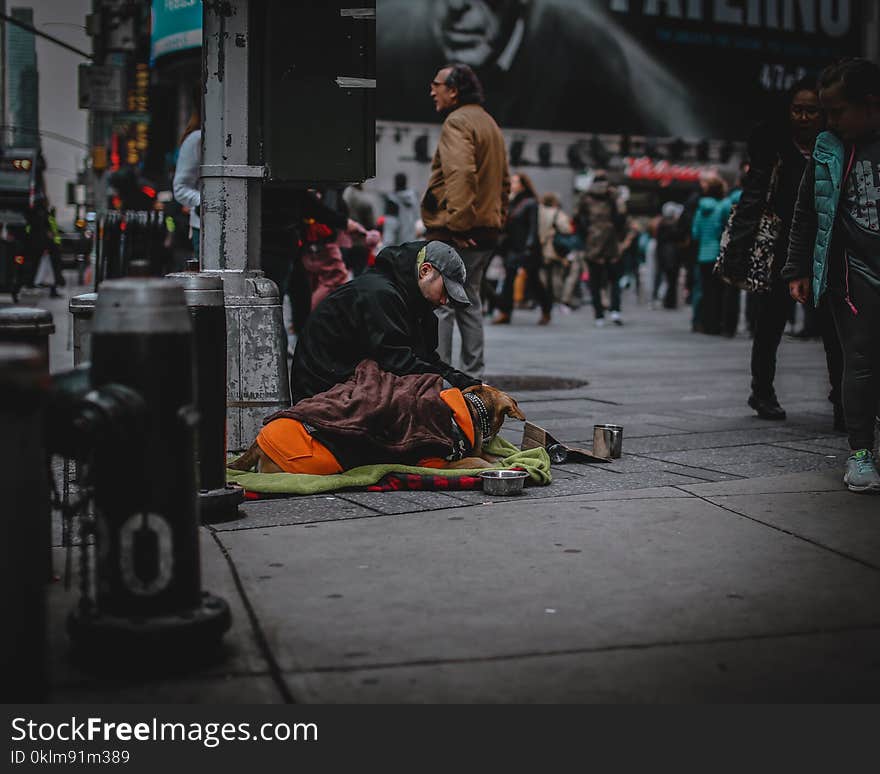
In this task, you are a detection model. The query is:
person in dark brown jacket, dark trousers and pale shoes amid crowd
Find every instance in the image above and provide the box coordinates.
[575,170,626,328]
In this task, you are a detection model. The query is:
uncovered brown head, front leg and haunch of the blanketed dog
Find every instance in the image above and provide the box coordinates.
[227,384,526,473]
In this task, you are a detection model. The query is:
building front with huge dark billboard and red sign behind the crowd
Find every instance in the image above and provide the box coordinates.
[370,0,880,213]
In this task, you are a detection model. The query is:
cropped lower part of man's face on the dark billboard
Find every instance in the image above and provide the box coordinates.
[432,0,529,67]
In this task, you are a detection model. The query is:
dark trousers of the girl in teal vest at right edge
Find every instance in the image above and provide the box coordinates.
[831,271,880,451]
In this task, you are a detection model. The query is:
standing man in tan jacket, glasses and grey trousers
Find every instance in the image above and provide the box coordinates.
[422,64,510,379]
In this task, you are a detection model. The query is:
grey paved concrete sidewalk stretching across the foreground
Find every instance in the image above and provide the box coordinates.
[15,278,880,703]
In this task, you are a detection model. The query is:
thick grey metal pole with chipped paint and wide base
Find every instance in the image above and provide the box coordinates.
[200,0,290,451]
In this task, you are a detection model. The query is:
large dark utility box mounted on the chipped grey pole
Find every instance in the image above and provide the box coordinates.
[254,0,376,186]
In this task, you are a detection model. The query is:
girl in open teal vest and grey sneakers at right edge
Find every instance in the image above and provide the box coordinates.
[782,59,880,494]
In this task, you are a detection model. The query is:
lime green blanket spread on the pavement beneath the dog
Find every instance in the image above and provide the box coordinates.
[226,437,552,495]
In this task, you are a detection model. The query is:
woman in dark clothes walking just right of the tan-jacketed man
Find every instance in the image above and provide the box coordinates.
[492,172,553,325]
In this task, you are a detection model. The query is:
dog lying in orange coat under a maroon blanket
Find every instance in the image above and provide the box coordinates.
[229,360,525,475]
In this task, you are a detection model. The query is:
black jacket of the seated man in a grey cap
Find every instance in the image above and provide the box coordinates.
[290,242,480,404]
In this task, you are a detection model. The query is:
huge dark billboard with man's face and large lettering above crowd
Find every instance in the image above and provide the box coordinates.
[376,0,863,139]
